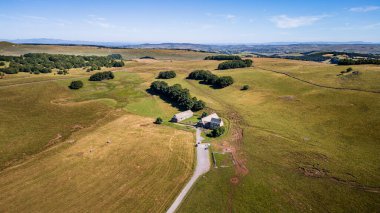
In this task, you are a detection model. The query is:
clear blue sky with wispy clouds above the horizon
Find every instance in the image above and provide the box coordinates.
[0,0,380,44]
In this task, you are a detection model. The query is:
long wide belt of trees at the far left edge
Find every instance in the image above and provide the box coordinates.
[0,53,124,74]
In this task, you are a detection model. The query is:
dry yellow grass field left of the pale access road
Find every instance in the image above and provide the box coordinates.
[0,114,194,212]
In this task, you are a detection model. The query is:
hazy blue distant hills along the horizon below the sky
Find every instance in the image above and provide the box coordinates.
[0,38,380,54]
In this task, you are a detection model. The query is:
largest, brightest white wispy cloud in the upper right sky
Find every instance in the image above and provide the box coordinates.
[270,15,326,29]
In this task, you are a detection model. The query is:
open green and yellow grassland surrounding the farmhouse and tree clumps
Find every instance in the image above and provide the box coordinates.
[0,44,380,212]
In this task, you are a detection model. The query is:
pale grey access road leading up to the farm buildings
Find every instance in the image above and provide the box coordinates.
[167,128,210,213]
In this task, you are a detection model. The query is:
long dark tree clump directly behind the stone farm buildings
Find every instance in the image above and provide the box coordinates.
[150,81,206,111]
